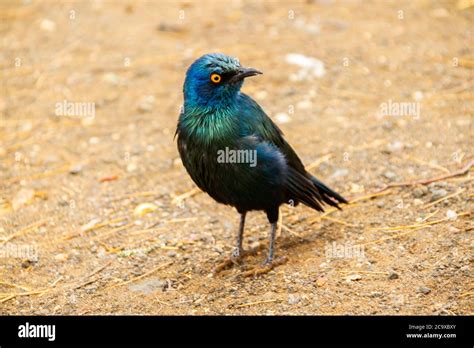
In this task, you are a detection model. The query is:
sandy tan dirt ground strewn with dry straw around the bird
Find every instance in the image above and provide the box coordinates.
[0,0,474,315]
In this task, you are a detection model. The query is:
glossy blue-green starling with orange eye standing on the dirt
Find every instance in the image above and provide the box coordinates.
[175,53,347,269]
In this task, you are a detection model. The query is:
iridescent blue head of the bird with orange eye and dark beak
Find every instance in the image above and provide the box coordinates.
[183,53,261,107]
